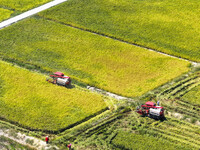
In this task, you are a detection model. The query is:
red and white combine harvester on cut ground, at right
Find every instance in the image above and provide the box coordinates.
[137,102,164,119]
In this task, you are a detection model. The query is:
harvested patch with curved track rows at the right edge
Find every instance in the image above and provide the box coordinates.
[156,71,200,119]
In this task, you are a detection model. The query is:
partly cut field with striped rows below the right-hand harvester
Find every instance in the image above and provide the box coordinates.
[67,109,200,150]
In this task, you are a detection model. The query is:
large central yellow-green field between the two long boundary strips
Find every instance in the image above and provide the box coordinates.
[0,18,190,97]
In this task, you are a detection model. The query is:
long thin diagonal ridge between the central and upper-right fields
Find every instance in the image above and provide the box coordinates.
[42,15,200,67]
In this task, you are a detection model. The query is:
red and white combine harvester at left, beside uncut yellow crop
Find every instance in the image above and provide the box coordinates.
[47,72,71,87]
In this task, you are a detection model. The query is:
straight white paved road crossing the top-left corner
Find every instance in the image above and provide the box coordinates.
[0,0,67,29]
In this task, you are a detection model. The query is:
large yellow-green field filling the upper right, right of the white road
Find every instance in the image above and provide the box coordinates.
[40,0,200,61]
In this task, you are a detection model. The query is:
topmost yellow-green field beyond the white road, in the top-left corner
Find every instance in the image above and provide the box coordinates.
[0,0,51,11]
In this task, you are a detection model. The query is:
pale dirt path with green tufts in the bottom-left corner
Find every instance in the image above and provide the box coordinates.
[0,129,59,150]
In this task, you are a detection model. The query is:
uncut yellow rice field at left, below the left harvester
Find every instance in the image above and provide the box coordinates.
[0,61,106,131]
